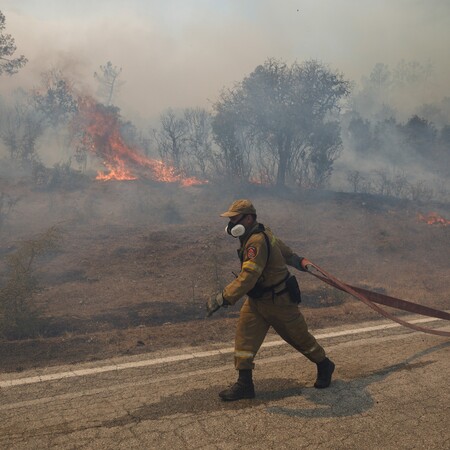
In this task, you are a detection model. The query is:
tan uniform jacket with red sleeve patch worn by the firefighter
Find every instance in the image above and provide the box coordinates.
[223,223,300,305]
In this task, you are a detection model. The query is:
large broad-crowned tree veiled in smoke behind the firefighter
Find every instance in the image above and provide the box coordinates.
[213,59,350,187]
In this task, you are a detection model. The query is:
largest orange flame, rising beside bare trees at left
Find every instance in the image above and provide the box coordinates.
[76,97,206,186]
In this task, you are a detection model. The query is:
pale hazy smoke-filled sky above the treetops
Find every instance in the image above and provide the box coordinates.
[0,0,450,118]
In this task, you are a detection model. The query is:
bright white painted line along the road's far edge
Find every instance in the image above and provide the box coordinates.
[0,317,440,388]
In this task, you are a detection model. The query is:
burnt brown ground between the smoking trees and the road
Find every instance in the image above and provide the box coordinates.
[0,180,450,371]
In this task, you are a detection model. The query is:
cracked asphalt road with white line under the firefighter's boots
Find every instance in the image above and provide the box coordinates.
[0,319,450,450]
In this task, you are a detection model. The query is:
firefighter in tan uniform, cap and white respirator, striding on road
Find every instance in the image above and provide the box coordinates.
[206,200,335,401]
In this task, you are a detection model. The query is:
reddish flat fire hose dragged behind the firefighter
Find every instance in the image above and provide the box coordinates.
[302,260,450,337]
